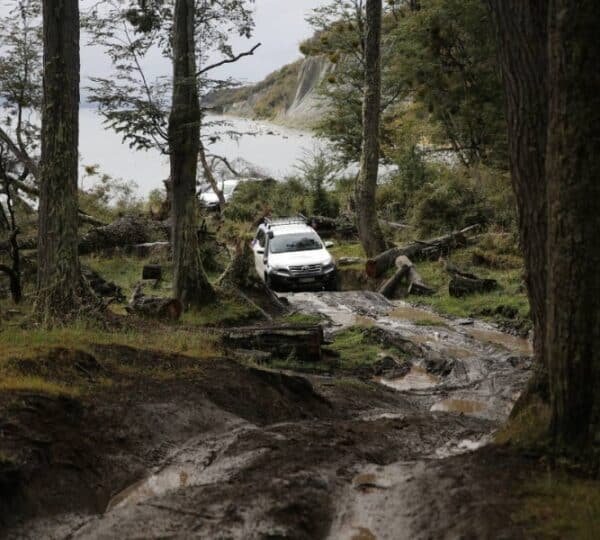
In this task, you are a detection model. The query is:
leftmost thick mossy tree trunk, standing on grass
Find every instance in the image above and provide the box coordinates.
[36,0,83,320]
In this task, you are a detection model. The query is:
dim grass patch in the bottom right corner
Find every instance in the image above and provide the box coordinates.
[513,472,600,540]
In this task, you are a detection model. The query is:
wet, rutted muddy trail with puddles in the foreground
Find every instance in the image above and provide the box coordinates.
[5,292,531,540]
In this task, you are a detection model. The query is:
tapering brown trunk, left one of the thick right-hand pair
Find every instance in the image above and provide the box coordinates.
[487,0,548,377]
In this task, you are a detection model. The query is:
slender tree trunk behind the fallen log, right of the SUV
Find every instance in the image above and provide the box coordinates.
[356,0,386,257]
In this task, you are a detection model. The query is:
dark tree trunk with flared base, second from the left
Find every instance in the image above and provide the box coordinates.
[169,0,214,308]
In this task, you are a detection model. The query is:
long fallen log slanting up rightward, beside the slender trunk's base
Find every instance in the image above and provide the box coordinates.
[365,225,479,278]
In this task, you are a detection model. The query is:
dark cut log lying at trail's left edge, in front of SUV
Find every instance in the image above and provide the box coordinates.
[222,324,323,362]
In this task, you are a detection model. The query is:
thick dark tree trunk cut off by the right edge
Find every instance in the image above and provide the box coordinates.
[546,0,600,454]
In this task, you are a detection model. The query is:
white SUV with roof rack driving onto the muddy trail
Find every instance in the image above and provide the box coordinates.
[252,217,336,290]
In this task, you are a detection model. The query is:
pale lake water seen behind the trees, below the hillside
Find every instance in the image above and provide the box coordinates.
[79,109,323,196]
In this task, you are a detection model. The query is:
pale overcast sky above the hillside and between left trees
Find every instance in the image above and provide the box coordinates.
[78,0,331,86]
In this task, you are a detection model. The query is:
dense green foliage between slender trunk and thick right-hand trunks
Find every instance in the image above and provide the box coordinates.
[391,0,508,169]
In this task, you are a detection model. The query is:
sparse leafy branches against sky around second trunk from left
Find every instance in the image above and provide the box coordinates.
[82,0,254,151]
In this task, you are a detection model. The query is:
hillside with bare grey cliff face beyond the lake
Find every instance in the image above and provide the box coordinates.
[204,56,332,127]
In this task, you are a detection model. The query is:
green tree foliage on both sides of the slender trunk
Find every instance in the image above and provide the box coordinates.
[301,0,508,169]
